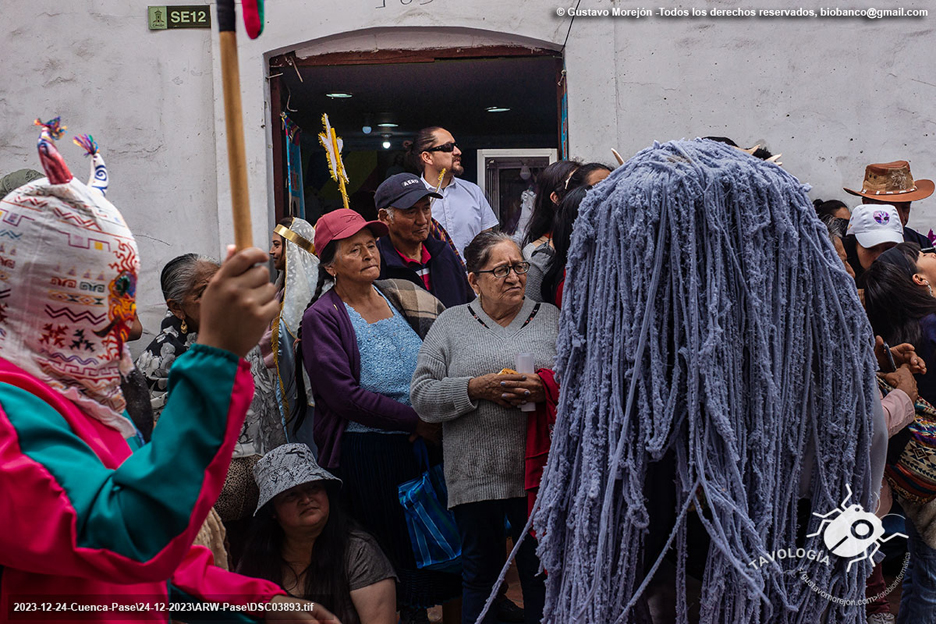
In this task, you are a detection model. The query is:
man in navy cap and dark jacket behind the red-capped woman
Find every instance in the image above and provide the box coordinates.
[374,173,474,308]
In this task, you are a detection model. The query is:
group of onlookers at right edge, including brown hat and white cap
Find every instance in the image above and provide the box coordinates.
[815,161,936,623]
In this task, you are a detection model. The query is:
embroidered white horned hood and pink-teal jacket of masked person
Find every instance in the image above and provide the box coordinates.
[0,119,285,622]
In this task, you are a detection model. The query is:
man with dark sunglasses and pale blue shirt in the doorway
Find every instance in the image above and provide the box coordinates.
[414,127,499,255]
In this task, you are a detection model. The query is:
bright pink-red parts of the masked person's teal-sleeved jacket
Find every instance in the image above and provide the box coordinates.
[0,359,284,622]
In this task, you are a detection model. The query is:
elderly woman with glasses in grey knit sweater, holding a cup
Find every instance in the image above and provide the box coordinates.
[410,232,559,622]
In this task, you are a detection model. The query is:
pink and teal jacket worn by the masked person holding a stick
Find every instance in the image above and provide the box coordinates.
[0,345,286,622]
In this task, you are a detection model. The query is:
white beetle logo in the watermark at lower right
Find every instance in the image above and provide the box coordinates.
[807,483,907,572]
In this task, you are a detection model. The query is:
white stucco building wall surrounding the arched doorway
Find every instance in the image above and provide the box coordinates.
[0,0,936,348]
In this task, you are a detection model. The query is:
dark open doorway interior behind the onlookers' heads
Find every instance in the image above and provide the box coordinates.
[270,47,564,239]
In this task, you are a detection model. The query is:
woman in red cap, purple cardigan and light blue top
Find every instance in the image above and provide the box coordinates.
[301,209,461,623]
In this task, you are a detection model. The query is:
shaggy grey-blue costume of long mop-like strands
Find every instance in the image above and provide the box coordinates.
[534,140,883,624]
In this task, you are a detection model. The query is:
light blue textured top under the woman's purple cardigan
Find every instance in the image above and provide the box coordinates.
[345,291,422,433]
